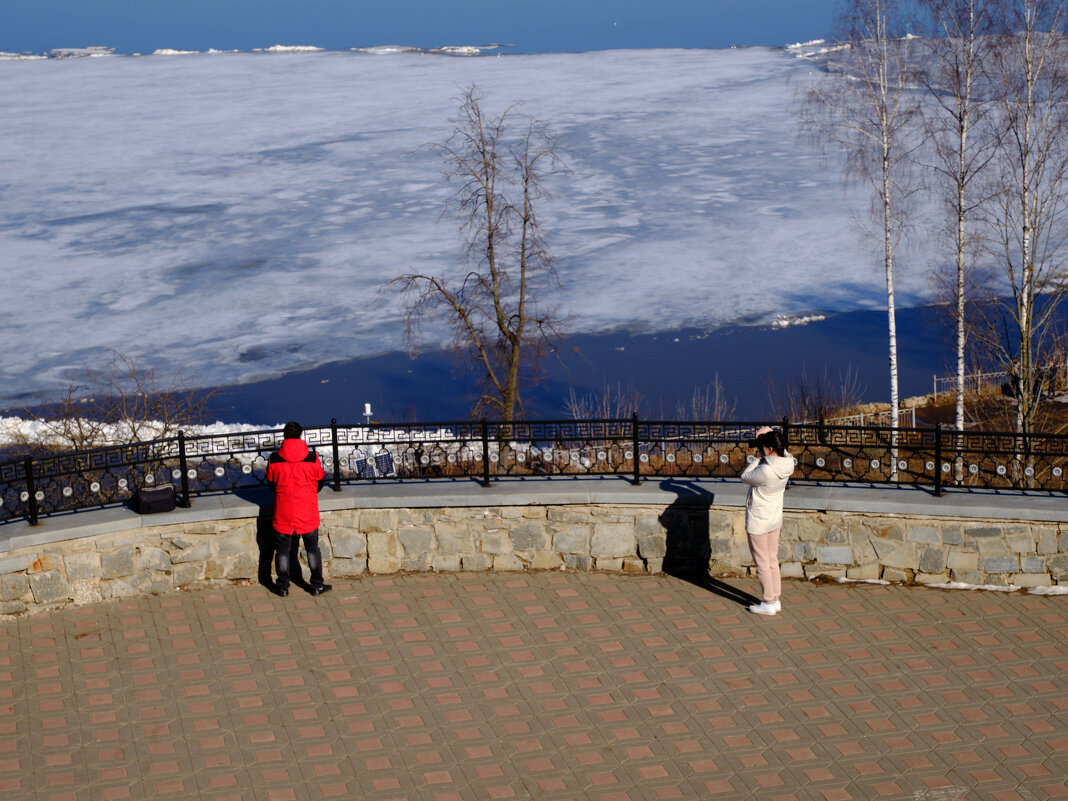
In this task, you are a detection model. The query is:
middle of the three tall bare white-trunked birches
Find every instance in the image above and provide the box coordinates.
[917,0,994,440]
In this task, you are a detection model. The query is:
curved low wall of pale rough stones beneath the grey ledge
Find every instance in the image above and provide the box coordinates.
[0,503,1068,614]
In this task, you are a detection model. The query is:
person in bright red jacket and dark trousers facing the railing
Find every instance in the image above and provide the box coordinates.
[267,421,331,596]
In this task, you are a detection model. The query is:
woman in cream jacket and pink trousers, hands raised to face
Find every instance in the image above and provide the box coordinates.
[741,427,797,615]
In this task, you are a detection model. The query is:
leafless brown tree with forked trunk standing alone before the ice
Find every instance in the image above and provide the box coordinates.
[390,85,563,421]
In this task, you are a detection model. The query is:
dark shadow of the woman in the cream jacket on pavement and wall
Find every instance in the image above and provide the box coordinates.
[660,478,760,607]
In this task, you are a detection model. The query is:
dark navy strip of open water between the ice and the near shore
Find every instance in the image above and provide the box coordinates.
[206,309,953,424]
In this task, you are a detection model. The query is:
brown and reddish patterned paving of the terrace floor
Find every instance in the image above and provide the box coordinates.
[0,572,1068,801]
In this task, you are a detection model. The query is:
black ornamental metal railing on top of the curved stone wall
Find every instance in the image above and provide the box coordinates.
[0,415,1068,524]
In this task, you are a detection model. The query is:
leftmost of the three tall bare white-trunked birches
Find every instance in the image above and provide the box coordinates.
[802,0,916,463]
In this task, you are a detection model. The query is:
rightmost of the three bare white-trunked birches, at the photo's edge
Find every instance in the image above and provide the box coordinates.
[980,0,1068,434]
